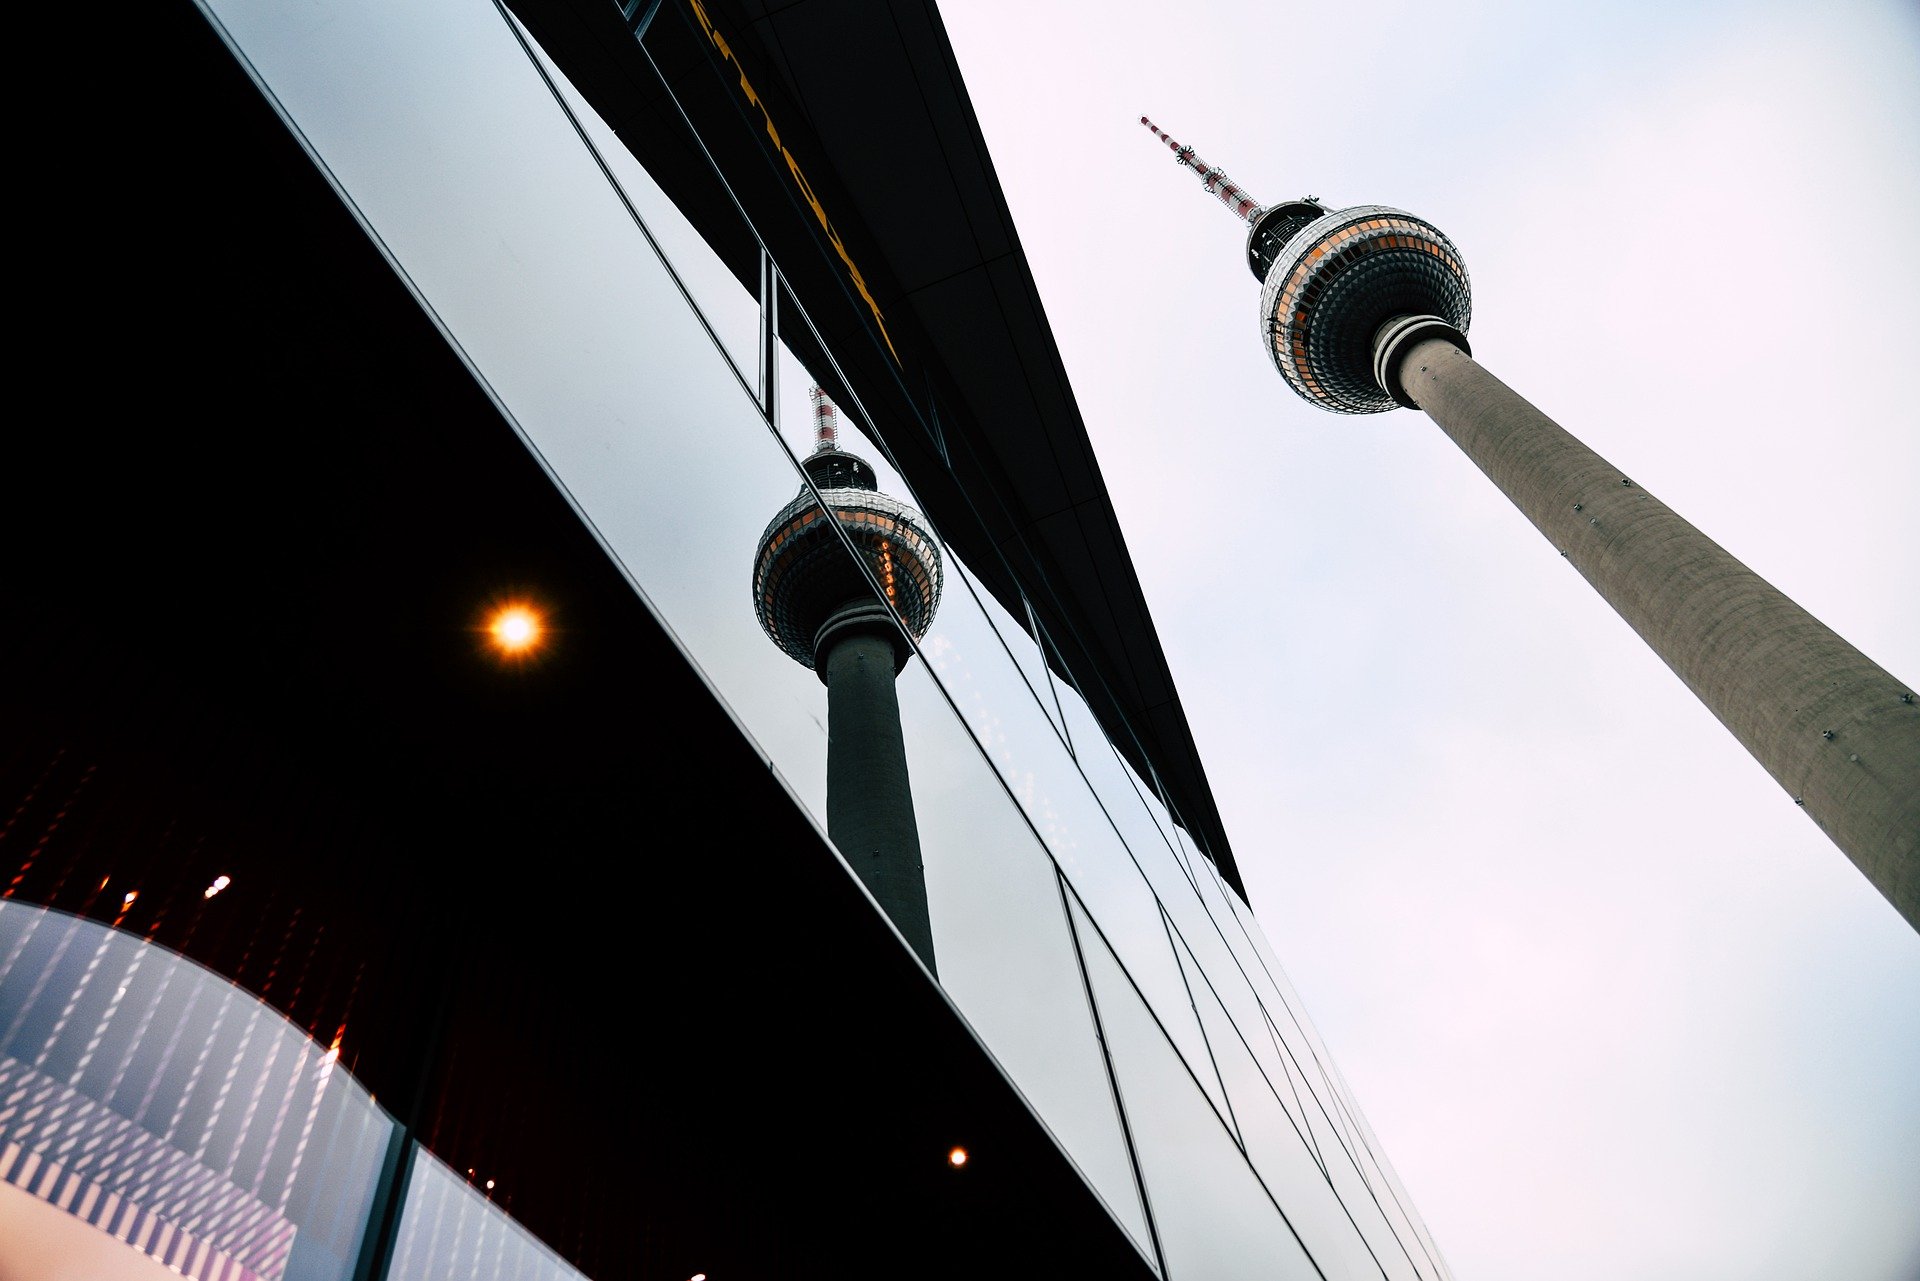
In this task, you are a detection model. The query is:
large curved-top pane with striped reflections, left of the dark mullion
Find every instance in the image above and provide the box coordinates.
[0,903,394,1281]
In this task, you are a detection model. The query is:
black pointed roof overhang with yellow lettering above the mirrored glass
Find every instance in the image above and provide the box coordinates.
[507,0,1244,895]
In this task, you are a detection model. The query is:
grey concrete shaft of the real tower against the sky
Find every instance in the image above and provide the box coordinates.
[1388,338,1920,930]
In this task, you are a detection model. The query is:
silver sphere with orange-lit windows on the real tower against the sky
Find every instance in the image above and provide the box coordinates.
[1260,205,1473,413]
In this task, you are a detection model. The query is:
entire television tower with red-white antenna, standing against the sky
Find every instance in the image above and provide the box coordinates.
[1140,115,1920,930]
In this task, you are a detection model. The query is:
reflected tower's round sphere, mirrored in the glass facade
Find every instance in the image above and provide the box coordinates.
[753,490,941,666]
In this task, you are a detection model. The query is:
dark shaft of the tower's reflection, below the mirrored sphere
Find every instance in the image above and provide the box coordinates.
[816,603,933,970]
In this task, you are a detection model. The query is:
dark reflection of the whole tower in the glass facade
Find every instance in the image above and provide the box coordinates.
[753,388,941,968]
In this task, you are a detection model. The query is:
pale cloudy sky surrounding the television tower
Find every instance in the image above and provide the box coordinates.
[943,0,1920,1281]
